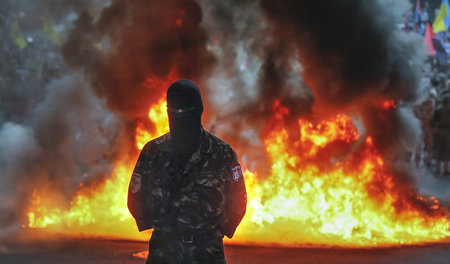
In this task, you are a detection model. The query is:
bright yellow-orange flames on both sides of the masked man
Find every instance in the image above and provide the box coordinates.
[28,92,450,247]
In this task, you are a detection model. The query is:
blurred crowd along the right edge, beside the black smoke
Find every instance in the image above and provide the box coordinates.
[401,0,450,175]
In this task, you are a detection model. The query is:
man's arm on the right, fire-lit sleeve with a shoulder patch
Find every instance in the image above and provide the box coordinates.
[221,147,247,238]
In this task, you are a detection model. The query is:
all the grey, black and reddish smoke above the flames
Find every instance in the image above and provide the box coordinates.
[0,0,444,237]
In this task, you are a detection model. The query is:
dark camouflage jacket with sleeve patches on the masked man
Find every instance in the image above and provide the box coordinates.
[128,129,247,238]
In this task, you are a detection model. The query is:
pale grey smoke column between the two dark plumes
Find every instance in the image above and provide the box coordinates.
[195,0,314,172]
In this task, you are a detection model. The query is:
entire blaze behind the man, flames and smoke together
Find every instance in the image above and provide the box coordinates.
[0,0,450,247]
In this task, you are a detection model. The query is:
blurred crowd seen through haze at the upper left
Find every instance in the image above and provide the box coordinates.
[0,10,65,124]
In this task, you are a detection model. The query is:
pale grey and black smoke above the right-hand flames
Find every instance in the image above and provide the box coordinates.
[200,0,423,175]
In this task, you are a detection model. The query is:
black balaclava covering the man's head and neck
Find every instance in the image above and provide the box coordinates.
[167,80,203,166]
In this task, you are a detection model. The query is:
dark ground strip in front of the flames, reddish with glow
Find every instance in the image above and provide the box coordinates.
[0,233,450,264]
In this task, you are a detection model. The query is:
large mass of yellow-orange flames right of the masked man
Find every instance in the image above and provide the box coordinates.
[232,108,450,247]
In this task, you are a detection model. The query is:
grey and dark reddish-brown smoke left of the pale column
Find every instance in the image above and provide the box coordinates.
[0,0,214,231]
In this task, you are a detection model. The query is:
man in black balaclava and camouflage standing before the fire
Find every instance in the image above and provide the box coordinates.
[128,80,247,264]
